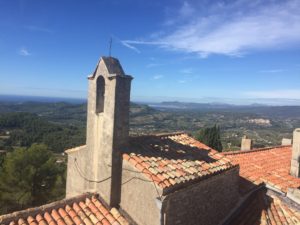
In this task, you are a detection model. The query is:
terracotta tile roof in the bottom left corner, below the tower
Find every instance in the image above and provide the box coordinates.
[0,194,129,225]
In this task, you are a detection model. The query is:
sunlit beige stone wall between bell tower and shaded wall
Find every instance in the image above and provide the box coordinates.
[120,161,162,225]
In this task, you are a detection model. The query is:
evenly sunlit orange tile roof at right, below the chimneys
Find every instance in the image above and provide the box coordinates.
[223,146,300,192]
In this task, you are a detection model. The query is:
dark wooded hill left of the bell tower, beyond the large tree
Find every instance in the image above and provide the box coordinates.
[0,112,85,152]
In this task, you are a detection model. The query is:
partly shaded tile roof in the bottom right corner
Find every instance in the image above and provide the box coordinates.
[225,189,300,225]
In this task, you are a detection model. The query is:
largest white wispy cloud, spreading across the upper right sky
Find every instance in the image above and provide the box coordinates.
[124,0,300,58]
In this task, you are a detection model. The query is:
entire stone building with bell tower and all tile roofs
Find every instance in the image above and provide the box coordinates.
[0,57,300,225]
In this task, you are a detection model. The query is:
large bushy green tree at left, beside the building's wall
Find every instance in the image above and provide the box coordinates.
[0,144,65,213]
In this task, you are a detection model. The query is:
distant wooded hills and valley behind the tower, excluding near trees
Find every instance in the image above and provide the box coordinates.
[0,102,300,152]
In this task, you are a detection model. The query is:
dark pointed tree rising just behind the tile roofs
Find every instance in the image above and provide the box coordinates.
[196,125,223,152]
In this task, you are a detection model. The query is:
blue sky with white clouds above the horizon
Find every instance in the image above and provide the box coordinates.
[0,0,300,104]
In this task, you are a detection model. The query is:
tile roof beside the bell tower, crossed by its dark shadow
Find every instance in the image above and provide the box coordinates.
[123,133,234,189]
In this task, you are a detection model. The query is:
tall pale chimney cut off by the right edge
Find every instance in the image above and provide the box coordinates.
[291,128,300,177]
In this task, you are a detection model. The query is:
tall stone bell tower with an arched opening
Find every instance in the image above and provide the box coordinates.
[85,57,132,206]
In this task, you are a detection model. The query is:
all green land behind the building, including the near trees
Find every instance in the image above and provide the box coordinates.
[0,102,300,214]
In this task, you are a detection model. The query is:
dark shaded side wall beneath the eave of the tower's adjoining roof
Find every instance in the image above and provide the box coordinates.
[164,167,239,225]
